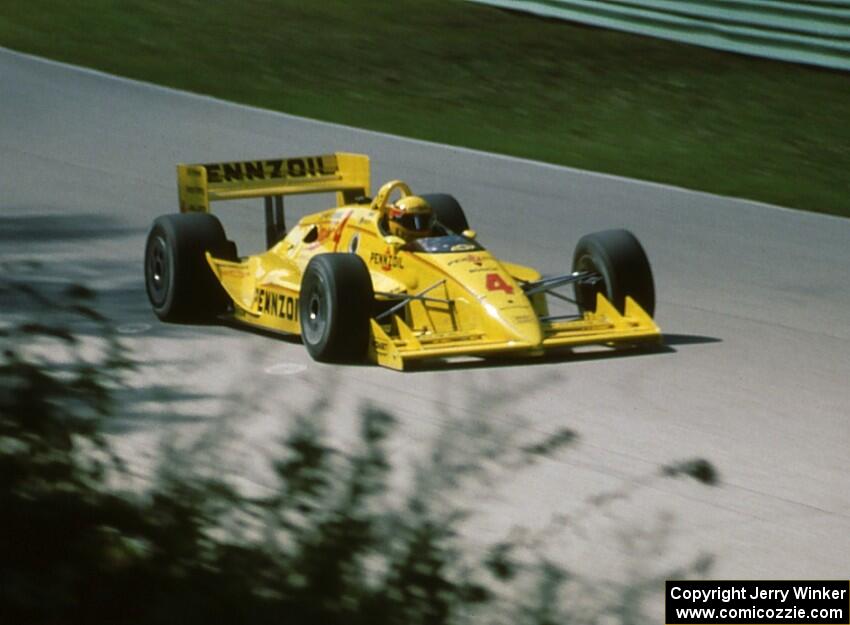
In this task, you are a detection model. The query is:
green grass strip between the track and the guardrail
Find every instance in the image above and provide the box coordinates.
[0,0,850,216]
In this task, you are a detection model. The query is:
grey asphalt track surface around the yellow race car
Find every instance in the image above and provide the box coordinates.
[0,51,850,601]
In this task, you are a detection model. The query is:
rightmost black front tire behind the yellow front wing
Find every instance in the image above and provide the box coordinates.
[573,230,655,315]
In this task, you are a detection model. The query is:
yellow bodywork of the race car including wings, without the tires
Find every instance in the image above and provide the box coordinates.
[178,153,660,370]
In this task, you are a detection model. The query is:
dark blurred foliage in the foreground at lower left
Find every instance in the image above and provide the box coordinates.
[0,283,716,625]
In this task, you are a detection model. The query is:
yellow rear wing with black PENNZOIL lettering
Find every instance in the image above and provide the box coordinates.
[177,152,369,213]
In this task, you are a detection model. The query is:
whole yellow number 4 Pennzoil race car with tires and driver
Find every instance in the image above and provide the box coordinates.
[145,153,661,370]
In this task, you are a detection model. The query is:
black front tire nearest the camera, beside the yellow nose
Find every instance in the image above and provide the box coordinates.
[299,254,375,362]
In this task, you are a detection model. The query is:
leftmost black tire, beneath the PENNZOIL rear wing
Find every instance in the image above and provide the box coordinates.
[145,213,233,322]
